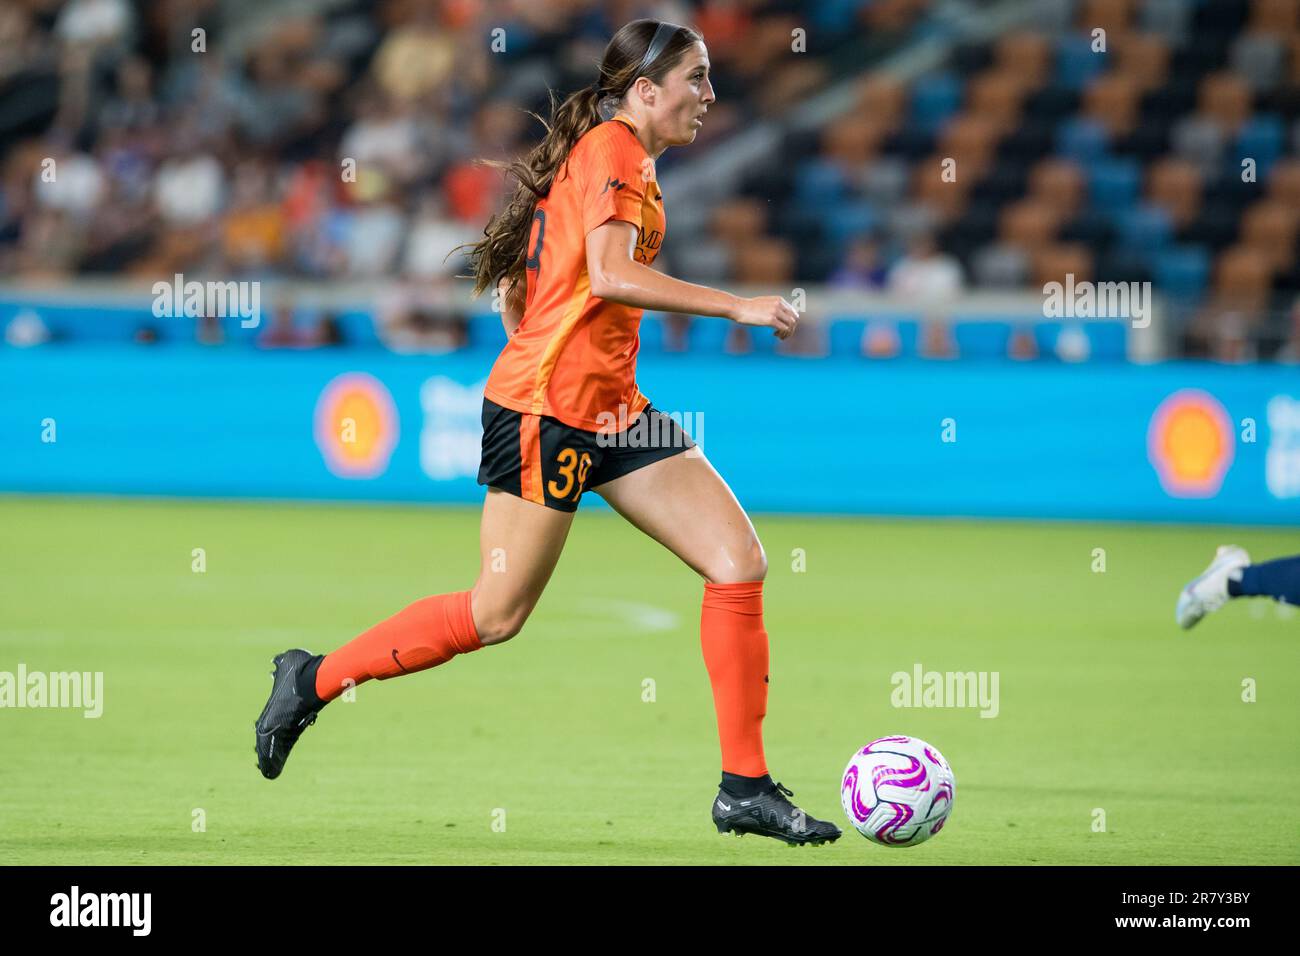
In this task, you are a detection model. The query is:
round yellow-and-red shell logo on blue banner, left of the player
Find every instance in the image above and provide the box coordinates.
[313,372,398,477]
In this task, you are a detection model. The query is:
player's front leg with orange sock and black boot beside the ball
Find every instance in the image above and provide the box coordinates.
[592,451,840,844]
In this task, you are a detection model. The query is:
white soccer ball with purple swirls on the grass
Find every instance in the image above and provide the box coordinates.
[840,736,957,847]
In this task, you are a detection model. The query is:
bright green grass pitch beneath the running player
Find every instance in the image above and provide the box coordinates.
[0,497,1300,866]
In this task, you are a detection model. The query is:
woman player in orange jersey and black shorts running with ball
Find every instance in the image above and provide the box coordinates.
[257,20,840,844]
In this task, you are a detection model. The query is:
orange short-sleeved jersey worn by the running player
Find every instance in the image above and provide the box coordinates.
[484,113,666,432]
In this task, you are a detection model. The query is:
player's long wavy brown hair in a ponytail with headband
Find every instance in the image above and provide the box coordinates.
[452,20,703,303]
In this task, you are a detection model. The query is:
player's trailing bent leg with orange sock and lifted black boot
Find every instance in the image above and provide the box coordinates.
[256,489,573,779]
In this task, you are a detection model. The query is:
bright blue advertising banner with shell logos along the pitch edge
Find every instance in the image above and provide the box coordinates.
[0,346,1300,524]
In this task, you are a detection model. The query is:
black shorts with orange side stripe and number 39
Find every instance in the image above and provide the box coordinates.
[478,398,696,511]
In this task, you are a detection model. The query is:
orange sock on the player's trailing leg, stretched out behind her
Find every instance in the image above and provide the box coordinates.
[316,591,482,700]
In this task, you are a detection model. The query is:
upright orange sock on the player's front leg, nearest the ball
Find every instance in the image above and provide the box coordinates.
[699,581,767,777]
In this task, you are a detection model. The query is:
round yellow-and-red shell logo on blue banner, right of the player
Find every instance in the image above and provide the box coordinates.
[1147,389,1235,498]
